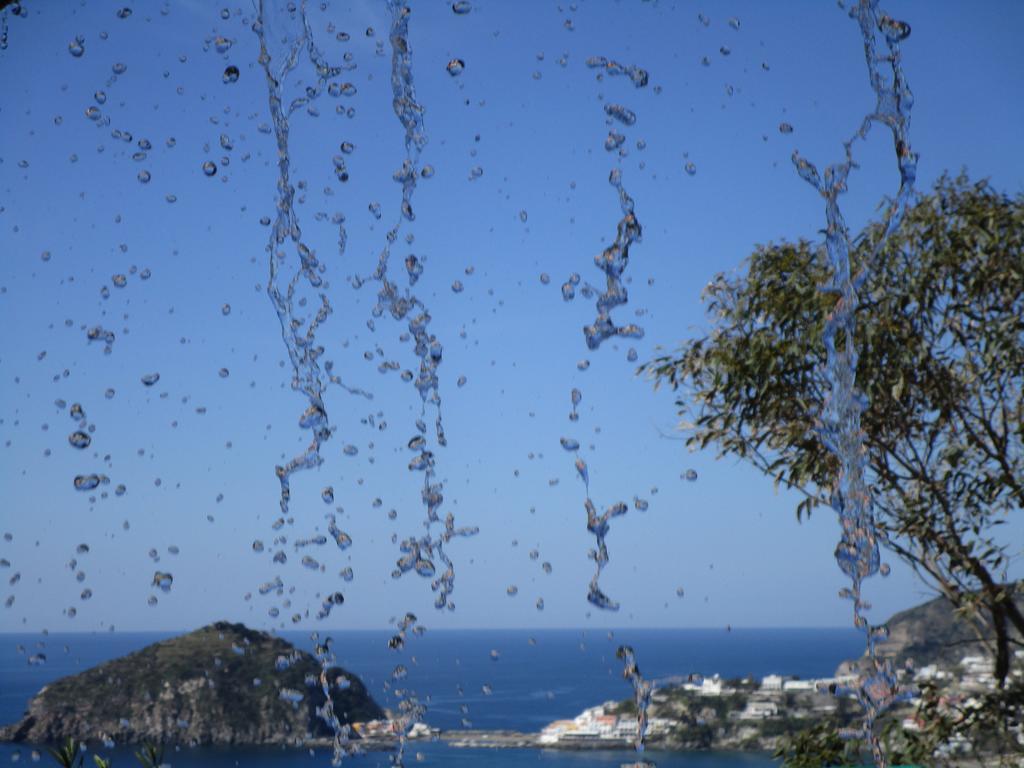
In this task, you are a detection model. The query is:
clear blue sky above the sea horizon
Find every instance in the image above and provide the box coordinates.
[0,0,1024,631]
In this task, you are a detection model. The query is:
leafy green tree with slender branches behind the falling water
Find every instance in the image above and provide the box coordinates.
[646,174,1024,686]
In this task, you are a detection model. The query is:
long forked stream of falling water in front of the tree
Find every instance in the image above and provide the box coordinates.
[793,0,918,768]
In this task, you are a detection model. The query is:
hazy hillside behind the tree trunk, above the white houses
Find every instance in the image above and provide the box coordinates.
[840,589,1024,671]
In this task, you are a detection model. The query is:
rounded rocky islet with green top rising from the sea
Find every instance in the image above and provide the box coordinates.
[0,622,384,744]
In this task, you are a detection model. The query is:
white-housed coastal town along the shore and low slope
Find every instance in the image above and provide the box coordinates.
[353,650,1024,757]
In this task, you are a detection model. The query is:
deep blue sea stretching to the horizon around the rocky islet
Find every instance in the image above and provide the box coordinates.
[0,629,863,768]
